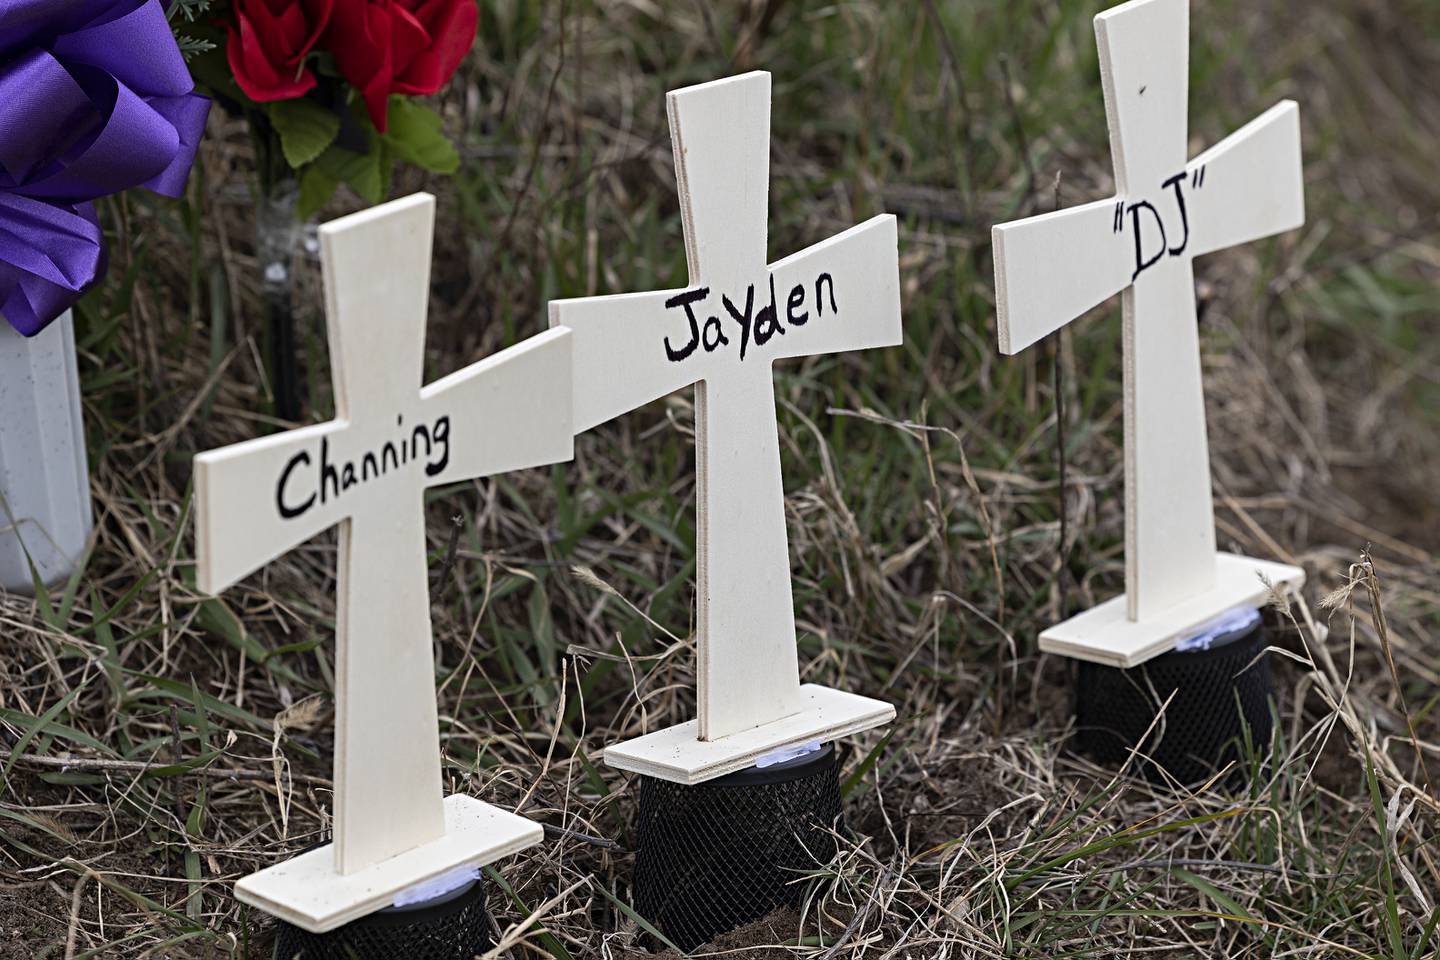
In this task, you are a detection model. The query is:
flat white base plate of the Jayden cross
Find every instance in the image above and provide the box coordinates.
[605,684,896,786]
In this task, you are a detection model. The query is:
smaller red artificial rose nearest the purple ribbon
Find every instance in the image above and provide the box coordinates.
[225,0,332,102]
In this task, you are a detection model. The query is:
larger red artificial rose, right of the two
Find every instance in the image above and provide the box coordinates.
[321,0,480,131]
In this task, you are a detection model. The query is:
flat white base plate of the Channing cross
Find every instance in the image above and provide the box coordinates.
[235,794,544,933]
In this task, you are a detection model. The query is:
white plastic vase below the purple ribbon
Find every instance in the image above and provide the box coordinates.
[0,312,92,594]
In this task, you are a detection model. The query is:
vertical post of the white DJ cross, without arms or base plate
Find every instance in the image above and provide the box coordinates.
[1096,0,1215,620]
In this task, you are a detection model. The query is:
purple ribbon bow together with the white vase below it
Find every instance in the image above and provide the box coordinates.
[0,0,210,594]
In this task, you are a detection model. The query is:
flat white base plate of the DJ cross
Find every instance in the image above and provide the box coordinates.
[1040,553,1305,668]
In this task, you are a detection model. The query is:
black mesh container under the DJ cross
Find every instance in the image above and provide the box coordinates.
[1076,622,1270,784]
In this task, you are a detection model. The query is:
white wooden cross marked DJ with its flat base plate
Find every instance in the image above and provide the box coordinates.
[994,0,1305,666]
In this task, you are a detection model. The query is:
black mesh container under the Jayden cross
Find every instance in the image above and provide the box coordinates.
[635,744,844,951]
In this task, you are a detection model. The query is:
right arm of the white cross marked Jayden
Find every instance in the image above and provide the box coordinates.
[770,213,903,357]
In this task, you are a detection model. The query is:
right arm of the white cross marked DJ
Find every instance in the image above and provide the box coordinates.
[1188,101,1305,256]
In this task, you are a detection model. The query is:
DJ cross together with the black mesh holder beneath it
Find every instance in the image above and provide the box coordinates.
[994,0,1305,782]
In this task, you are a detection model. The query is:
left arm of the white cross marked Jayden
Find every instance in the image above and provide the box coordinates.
[550,291,704,433]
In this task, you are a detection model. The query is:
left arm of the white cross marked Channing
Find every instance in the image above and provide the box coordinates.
[194,420,348,593]
